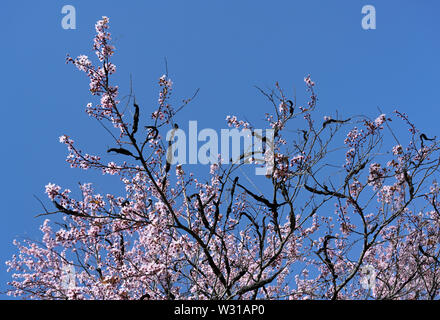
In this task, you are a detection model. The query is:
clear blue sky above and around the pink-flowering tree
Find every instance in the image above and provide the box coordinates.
[0,0,440,298]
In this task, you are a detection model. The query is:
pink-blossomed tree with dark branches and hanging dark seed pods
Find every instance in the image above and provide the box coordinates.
[7,17,440,299]
